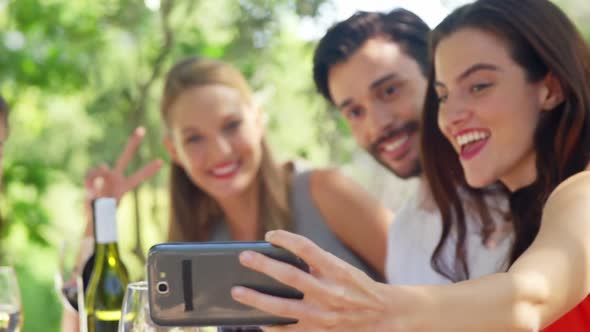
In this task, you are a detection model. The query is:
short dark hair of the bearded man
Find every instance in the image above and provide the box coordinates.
[313,8,430,103]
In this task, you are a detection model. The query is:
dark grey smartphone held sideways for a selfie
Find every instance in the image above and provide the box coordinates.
[147,241,308,326]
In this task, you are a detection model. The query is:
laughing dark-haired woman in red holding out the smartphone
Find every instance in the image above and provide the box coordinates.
[233,0,590,332]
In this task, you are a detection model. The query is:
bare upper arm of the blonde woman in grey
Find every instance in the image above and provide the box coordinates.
[310,169,393,275]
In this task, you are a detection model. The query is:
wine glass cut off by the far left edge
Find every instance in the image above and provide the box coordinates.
[0,266,23,332]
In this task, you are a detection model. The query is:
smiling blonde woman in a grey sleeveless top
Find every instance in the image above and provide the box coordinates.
[161,58,391,277]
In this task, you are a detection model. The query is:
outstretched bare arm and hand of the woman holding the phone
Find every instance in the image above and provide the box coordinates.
[232,172,590,332]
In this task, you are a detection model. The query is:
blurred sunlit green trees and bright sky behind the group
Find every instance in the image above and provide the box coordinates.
[0,0,590,332]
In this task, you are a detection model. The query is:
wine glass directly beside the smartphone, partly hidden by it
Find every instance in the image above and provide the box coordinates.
[119,281,207,332]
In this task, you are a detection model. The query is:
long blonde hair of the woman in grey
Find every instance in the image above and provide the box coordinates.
[161,58,291,241]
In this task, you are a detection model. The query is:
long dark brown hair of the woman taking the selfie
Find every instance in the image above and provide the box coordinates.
[421,0,590,280]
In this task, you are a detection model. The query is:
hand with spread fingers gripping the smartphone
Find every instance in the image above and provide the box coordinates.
[232,231,397,332]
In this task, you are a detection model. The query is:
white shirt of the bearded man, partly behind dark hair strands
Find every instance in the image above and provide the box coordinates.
[385,187,513,285]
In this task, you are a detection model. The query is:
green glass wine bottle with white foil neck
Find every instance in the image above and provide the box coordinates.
[84,198,129,332]
